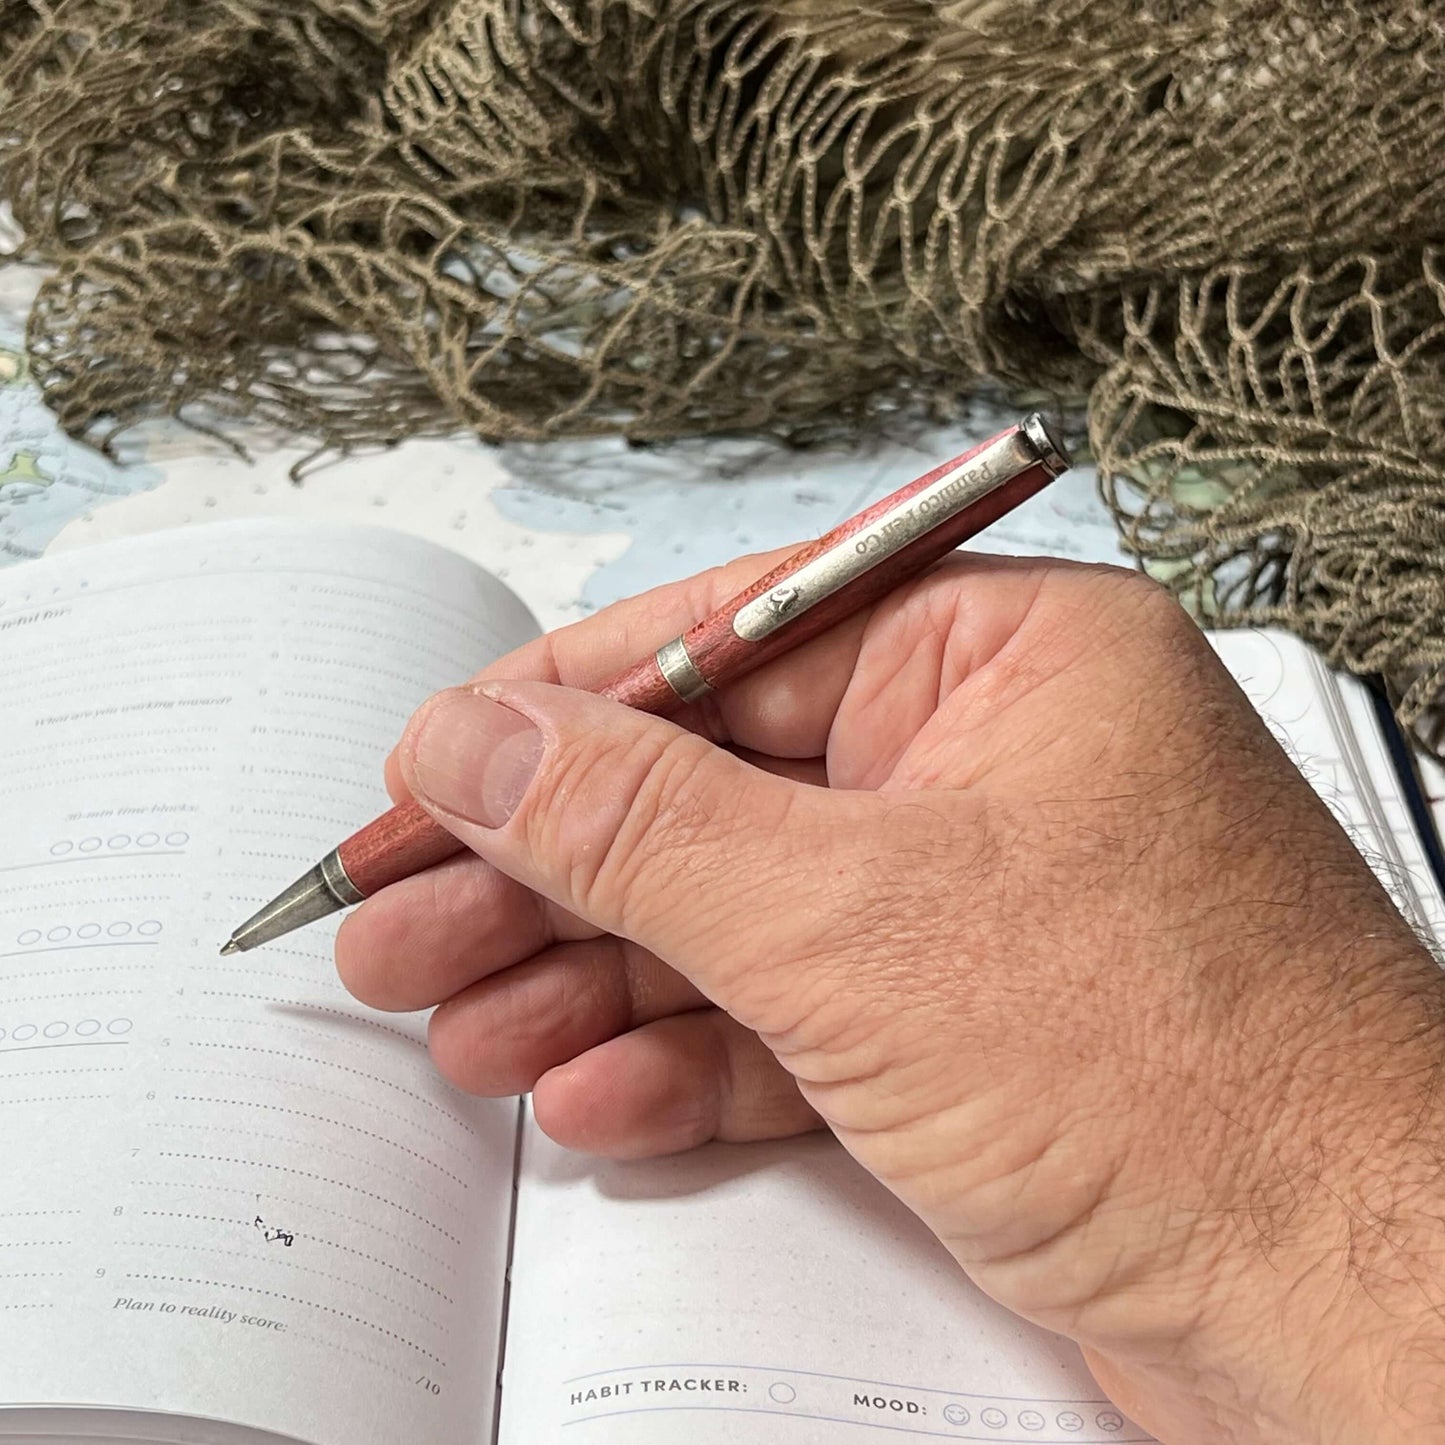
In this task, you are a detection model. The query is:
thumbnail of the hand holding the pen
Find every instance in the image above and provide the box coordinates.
[413,688,542,828]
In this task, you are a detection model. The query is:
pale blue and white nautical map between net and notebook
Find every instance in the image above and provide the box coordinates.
[0,266,1121,627]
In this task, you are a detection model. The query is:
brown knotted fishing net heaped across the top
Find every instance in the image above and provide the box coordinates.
[0,0,1445,743]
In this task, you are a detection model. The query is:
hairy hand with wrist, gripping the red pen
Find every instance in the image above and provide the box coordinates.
[337,553,1445,1445]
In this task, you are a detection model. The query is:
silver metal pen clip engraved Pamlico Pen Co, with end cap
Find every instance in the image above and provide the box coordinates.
[733,416,1068,642]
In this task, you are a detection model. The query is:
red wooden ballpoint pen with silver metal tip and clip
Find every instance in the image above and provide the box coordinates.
[221,413,1069,954]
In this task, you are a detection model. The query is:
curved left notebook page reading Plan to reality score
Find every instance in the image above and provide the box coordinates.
[0,523,535,1445]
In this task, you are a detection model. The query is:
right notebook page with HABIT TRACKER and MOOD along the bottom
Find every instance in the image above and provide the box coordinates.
[501,1118,1149,1445]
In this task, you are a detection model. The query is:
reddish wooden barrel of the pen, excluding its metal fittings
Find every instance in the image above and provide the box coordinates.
[337,428,1066,897]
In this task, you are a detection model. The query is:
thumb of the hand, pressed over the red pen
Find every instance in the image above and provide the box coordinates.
[399,682,868,1007]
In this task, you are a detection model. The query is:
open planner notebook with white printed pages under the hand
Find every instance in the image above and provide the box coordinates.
[0,523,1442,1445]
